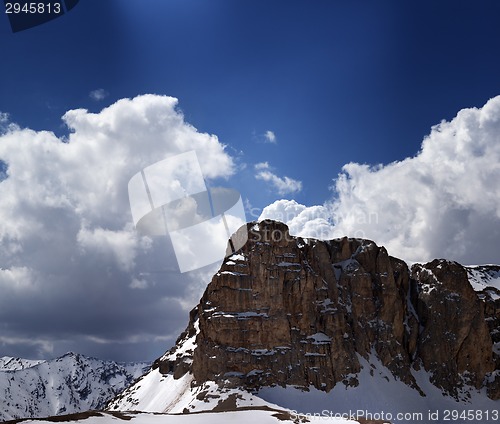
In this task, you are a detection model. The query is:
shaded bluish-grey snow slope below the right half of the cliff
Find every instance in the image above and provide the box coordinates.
[258,355,500,424]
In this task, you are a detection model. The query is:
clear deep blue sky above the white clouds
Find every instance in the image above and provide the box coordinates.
[0,0,500,207]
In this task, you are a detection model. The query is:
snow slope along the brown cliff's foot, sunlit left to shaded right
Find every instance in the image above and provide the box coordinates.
[110,322,500,424]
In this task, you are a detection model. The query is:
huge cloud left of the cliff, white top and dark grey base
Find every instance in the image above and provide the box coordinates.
[0,95,234,360]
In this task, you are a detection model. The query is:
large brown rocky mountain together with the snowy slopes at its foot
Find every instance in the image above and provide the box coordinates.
[108,221,500,420]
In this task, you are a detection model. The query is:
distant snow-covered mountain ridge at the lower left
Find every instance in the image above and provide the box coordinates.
[0,353,149,421]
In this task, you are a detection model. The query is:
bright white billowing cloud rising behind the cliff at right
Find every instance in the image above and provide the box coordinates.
[261,97,500,264]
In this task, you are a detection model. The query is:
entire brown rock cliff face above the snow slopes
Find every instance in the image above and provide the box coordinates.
[155,221,500,399]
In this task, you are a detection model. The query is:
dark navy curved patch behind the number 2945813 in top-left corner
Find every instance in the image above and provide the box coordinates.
[4,0,80,32]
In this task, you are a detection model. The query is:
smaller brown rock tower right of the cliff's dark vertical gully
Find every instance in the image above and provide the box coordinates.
[412,260,498,396]
